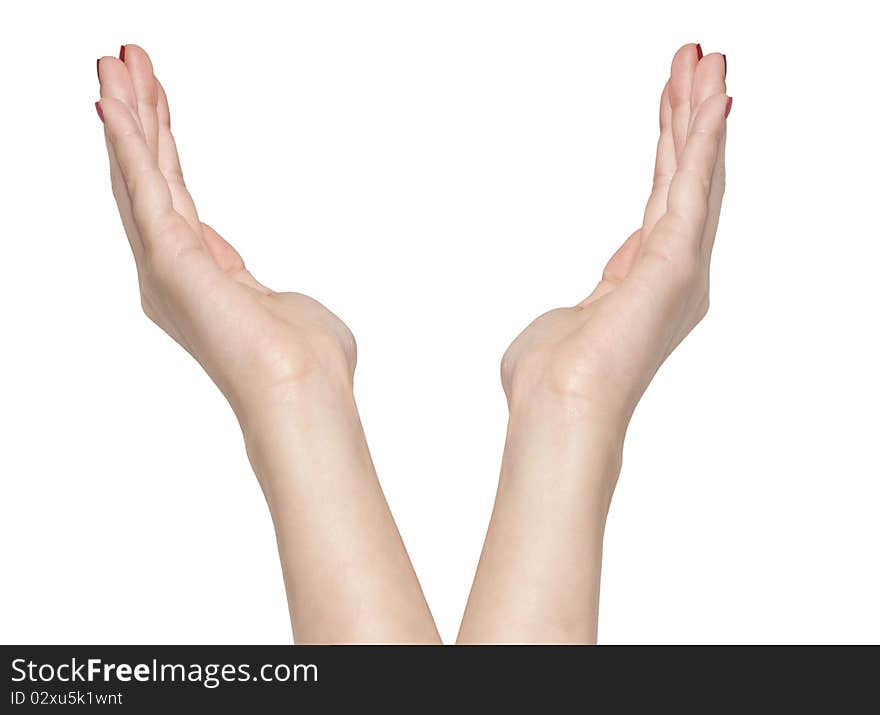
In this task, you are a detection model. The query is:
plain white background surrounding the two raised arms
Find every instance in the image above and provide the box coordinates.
[0,0,880,643]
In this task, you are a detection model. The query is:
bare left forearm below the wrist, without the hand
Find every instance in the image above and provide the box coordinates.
[242,380,439,643]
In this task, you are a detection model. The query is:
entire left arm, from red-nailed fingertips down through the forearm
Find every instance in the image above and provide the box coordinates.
[97,45,439,643]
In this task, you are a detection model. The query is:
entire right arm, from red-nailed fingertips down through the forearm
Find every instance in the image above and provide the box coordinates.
[459,45,730,643]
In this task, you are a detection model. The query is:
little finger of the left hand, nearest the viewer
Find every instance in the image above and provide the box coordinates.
[100,97,195,250]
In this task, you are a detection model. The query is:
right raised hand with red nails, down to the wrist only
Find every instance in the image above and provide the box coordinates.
[502,44,732,435]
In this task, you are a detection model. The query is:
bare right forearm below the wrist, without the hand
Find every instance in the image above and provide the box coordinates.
[459,397,623,643]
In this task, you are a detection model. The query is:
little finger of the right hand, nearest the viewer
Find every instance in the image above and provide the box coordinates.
[649,94,731,249]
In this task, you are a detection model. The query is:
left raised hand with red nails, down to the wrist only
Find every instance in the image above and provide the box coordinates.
[96,45,356,417]
